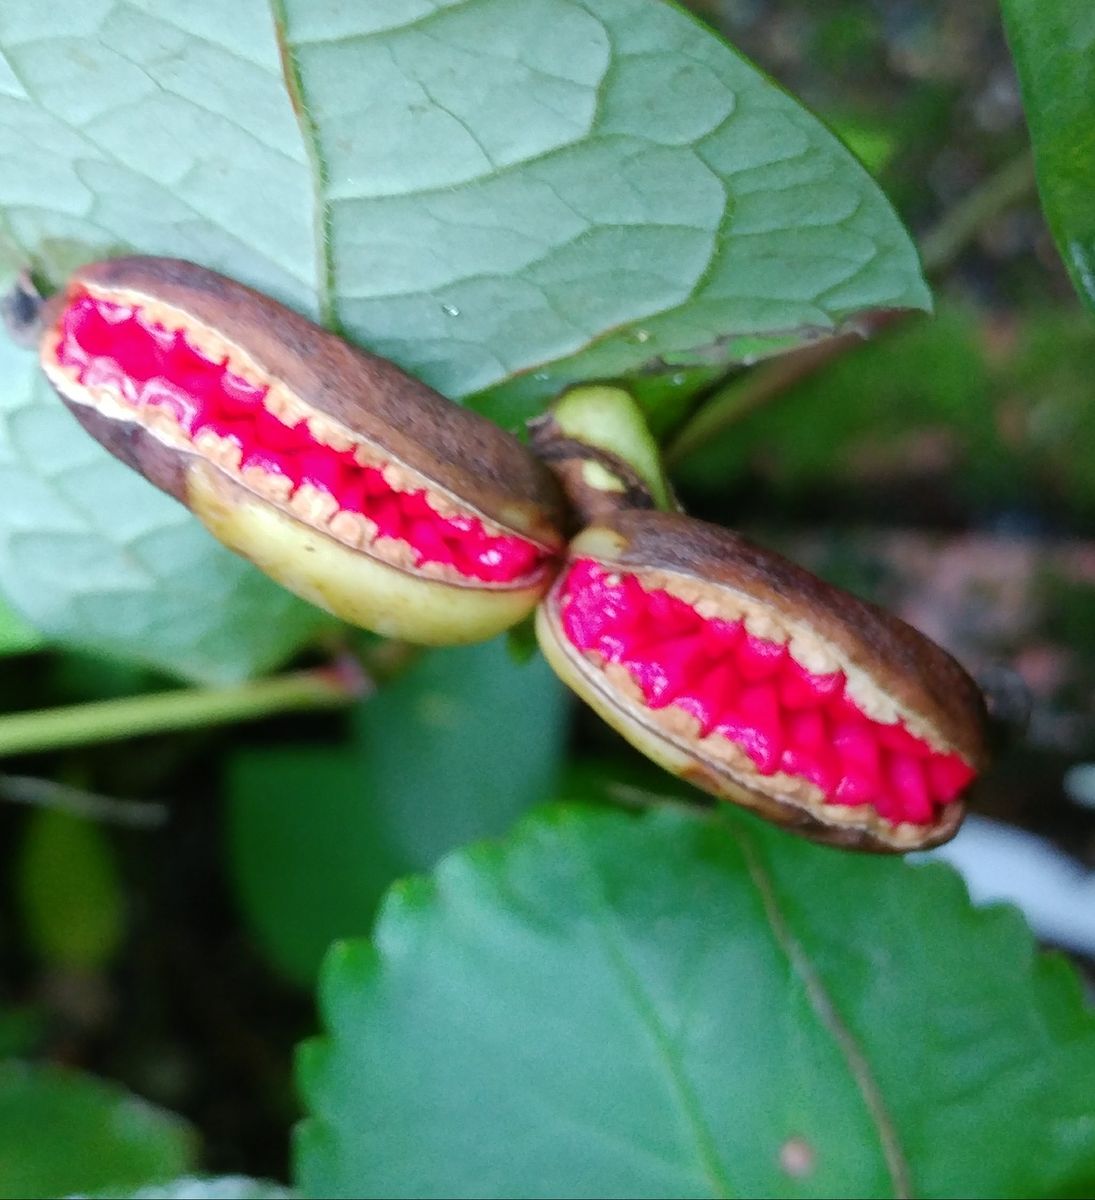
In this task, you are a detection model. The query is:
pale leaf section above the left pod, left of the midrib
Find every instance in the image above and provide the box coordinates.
[0,0,321,314]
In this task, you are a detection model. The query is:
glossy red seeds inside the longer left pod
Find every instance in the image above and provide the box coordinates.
[56,293,545,584]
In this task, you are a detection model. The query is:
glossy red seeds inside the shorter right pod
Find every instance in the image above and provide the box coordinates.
[562,558,974,824]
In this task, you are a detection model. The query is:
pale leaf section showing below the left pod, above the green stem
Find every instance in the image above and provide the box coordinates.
[0,337,330,683]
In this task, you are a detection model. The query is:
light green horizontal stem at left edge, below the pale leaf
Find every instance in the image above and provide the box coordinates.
[0,666,361,756]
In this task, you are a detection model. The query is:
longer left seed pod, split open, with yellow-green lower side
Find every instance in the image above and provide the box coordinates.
[40,258,562,644]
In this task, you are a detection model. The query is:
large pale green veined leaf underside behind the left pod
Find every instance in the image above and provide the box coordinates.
[0,0,927,678]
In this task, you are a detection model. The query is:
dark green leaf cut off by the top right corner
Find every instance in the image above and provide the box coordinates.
[1003,0,1095,310]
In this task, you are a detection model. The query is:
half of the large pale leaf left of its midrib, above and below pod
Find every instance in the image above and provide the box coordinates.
[0,0,336,682]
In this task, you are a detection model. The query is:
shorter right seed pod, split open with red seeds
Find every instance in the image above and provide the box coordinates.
[537,512,985,852]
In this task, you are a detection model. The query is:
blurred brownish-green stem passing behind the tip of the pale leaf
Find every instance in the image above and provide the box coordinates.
[663,151,1035,467]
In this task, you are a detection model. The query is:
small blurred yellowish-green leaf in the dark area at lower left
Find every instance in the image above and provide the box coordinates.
[17,809,125,970]
